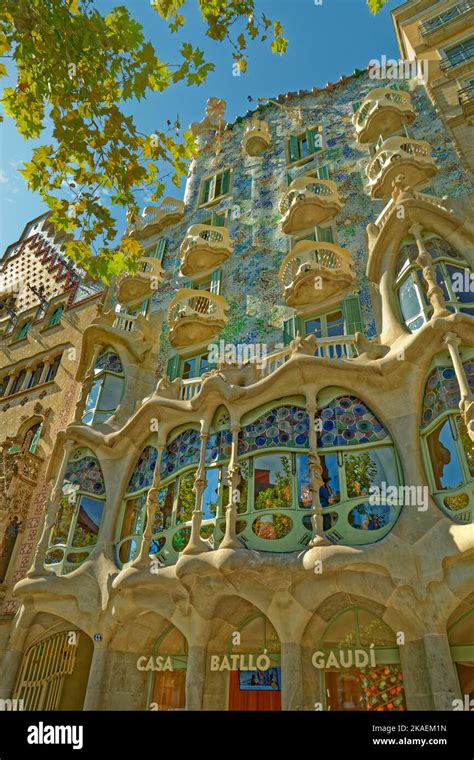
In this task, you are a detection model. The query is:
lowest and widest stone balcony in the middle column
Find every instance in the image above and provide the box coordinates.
[278,240,355,306]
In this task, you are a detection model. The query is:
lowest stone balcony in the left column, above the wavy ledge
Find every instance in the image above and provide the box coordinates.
[168,288,229,348]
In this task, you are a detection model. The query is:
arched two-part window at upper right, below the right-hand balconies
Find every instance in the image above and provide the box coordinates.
[396,237,474,332]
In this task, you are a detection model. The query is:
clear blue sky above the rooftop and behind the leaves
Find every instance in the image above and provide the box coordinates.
[0,0,401,254]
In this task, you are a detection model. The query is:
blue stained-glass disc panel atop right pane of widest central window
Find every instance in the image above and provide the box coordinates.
[318,396,388,448]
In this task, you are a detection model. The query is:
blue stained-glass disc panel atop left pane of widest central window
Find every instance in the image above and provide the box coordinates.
[239,406,309,455]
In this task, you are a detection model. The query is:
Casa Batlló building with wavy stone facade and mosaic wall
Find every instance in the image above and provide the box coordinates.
[0,1,474,711]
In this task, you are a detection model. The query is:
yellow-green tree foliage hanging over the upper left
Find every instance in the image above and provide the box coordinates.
[0,0,287,281]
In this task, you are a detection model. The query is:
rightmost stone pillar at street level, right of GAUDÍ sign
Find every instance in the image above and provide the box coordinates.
[424,633,461,710]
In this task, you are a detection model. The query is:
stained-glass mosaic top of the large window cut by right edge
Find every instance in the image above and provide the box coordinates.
[421,360,474,427]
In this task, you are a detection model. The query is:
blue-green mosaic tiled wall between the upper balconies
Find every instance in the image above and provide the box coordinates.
[147,72,468,372]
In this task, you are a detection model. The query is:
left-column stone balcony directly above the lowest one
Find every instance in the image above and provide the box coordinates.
[179,224,232,276]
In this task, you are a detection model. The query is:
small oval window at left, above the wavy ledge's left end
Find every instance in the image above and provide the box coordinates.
[82,348,124,425]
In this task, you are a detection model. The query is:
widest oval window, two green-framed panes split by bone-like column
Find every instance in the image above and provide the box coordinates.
[235,396,401,551]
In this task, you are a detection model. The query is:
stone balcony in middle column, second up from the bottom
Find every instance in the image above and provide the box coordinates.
[280,176,343,235]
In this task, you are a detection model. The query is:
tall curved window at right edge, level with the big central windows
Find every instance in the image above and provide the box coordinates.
[421,356,474,523]
